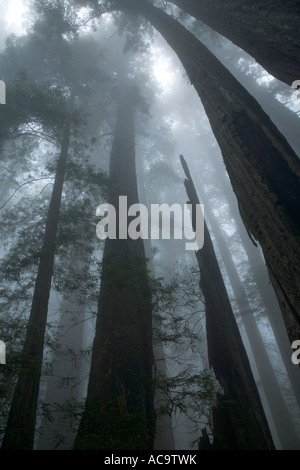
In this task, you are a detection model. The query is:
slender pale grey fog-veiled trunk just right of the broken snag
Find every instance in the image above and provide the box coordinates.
[200,186,300,450]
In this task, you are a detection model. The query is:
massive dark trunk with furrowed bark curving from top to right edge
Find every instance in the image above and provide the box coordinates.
[115,0,300,342]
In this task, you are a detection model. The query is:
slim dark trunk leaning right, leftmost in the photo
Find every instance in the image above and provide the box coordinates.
[2,112,71,450]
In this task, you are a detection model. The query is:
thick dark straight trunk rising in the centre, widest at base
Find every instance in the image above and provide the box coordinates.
[75,91,155,451]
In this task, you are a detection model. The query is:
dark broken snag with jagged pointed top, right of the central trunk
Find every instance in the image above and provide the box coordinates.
[181,156,274,450]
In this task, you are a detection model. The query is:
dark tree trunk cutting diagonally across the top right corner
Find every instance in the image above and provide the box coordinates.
[168,0,300,86]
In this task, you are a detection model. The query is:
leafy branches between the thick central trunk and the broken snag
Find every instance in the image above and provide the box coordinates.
[151,267,220,444]
